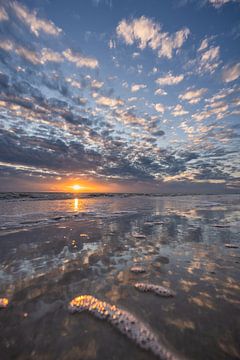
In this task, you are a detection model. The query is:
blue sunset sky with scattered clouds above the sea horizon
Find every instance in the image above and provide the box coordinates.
[0,0,240,193]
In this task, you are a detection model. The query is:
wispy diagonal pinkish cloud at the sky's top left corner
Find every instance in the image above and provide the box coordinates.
[12,2,62,36]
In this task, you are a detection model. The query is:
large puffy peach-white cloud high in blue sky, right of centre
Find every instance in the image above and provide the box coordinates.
[116,16,190,59]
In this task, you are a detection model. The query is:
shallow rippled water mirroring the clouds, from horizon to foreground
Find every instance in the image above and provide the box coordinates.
[0,195,240,360]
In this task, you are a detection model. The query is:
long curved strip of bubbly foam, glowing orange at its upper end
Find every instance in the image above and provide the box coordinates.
[69,295,179,360]
